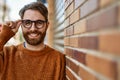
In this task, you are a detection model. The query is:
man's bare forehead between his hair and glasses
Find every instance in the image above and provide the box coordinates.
[23,9,45,20]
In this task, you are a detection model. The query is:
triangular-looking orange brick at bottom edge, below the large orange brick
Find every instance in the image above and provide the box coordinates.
[79,67,98,80]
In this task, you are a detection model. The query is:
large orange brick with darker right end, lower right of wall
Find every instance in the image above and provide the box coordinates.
[86,55,117,80]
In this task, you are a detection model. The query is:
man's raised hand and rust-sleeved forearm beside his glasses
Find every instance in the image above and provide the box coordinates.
[0,20,21,51]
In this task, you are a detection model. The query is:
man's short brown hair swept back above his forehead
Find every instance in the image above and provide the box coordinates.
[19,2,48,21]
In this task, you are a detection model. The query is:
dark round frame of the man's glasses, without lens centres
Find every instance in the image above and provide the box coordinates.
[21,19,47,29]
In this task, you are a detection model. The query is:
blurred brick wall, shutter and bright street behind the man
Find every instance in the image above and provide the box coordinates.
[0,0,120,80]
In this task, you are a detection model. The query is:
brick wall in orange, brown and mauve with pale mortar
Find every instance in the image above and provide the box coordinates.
[63,0,120,80]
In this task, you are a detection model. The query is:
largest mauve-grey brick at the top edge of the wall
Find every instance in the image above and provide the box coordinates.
[80,0,99,18]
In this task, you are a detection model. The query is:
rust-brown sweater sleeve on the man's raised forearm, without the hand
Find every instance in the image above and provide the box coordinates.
[0,25,15,51]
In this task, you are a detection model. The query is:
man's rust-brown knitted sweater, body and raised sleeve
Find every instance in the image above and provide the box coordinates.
[0,25,65,80]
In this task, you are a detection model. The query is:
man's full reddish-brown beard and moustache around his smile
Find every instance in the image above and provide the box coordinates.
[23,30,46,45]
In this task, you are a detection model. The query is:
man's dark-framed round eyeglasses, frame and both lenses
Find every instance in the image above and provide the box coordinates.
[22,20,47,29]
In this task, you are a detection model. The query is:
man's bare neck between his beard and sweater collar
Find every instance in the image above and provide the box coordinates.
[25,42,45,51]
